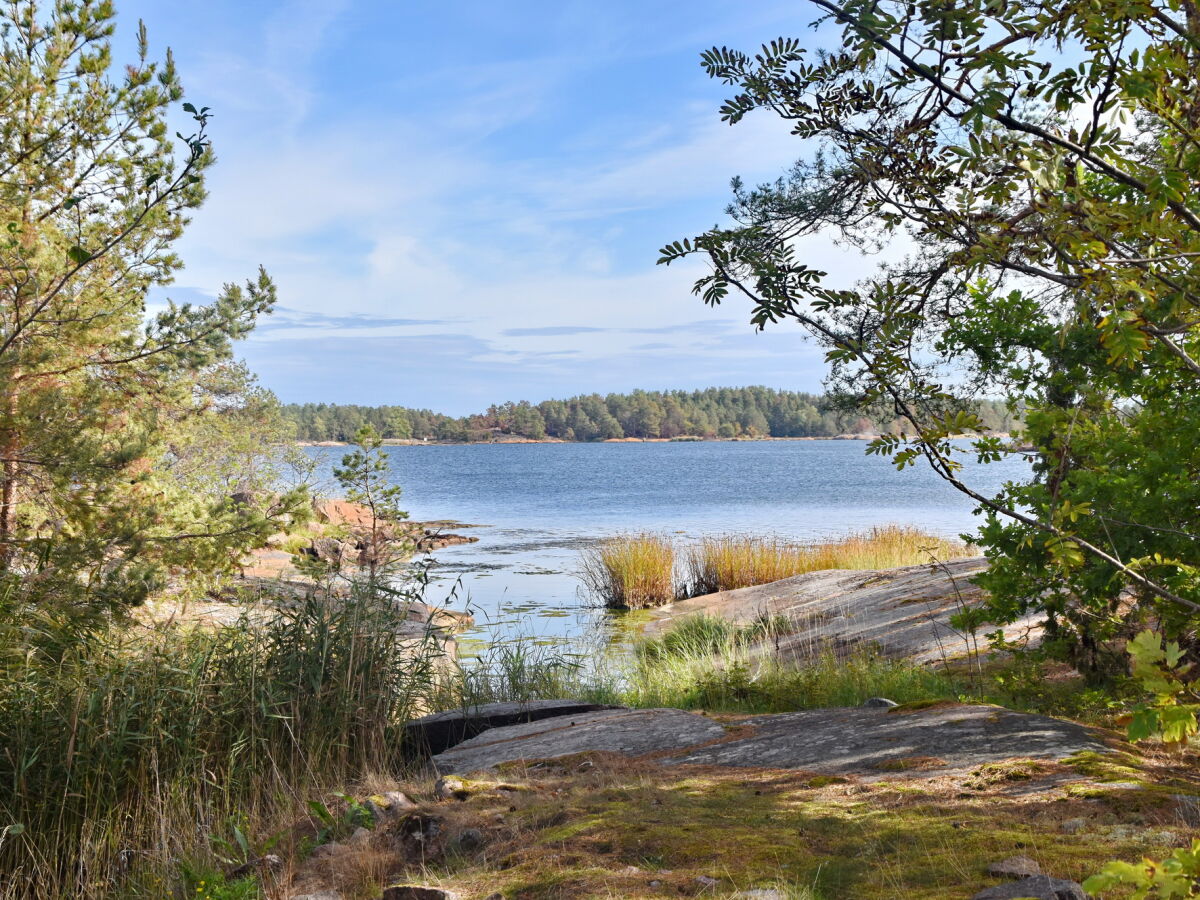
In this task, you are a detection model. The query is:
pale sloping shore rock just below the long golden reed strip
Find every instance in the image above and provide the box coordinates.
[647,559,1040,662]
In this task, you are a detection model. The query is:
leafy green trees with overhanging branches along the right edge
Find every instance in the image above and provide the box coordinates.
[660,0,1200,672]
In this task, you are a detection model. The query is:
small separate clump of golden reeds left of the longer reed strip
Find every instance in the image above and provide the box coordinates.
[581,534,676,610]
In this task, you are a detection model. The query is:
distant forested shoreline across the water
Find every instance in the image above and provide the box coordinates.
[283,386,1016,443]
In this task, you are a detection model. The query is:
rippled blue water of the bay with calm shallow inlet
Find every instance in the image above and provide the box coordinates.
[310,440,1026,641]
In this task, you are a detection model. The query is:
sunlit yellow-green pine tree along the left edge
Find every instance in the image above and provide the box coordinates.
[0,0,302,616]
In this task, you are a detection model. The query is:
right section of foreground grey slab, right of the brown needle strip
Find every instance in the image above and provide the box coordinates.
[664,703,1108,778]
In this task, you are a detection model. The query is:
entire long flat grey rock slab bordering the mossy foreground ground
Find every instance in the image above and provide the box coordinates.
[433,703,1108,779]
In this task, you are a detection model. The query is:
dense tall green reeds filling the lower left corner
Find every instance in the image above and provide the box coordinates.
[0,590,440,898]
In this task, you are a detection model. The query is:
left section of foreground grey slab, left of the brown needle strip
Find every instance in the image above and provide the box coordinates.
[433,709,725,774]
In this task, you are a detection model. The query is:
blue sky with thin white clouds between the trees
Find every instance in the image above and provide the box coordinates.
[116,0,864,415]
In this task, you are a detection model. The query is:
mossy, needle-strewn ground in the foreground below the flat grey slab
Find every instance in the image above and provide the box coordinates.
[350,755,1192,900]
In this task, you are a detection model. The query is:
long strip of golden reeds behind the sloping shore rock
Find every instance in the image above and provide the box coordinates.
[684,526,970,596]
